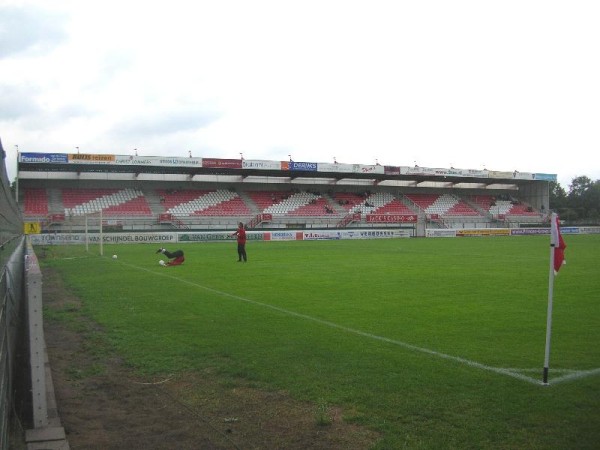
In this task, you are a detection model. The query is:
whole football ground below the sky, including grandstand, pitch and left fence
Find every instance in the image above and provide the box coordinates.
[0,143,600,449]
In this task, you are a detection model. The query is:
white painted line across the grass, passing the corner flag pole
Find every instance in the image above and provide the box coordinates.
[123,263,600,385]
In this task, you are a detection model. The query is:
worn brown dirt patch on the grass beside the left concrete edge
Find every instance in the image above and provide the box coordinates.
[44,269,377,450]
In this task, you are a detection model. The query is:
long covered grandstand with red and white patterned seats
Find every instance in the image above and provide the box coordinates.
[17,153,556,236]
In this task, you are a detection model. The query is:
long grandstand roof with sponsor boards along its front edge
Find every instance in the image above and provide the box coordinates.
[18,153,556,189]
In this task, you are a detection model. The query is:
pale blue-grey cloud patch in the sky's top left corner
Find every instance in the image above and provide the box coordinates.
[0,5,67,59]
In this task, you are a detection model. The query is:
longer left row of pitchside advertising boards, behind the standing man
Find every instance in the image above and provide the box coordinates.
[29,229,413,246]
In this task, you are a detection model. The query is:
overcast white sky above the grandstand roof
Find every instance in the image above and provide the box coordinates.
[0,0,600,189]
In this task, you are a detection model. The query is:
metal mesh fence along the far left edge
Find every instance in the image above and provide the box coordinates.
[0,141,27,449]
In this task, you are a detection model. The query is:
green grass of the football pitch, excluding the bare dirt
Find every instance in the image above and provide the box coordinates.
[43,236,600,449]
